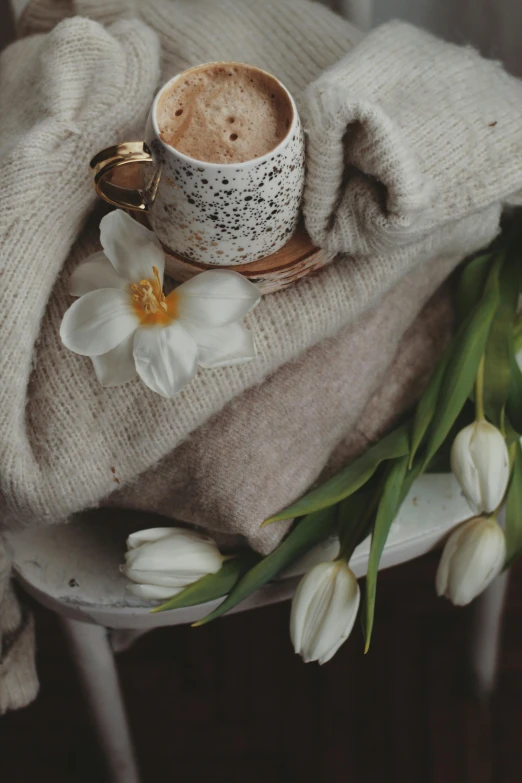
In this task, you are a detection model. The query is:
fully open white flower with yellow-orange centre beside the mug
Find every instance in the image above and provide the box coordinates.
[60,210,260,397]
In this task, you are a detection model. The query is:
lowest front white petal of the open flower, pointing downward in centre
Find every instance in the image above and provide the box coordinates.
[134,321,198,397]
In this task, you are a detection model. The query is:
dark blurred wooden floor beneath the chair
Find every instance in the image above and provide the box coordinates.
[0,555,522,783]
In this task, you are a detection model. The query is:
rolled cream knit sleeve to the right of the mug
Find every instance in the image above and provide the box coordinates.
[303,22,522,258]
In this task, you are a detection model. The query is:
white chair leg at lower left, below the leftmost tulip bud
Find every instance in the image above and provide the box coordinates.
[60,617,139,783]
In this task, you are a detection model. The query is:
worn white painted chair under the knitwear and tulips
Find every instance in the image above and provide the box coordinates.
[10,474,506,783]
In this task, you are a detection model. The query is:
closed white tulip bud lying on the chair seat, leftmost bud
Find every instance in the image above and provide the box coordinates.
[120,527,223,600]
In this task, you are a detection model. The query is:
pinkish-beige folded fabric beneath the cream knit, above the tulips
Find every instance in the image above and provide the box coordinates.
[104,254,454,554]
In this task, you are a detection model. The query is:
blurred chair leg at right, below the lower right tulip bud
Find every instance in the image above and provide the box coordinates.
[470,571,508,698]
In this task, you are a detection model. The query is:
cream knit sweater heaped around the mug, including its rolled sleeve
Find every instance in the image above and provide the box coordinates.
[0,0,522,712]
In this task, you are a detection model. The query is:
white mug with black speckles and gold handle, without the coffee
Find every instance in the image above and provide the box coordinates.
[91,63,305,266]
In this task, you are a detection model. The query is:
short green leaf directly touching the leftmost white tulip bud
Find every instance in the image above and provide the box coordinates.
[152,550,261,613]
